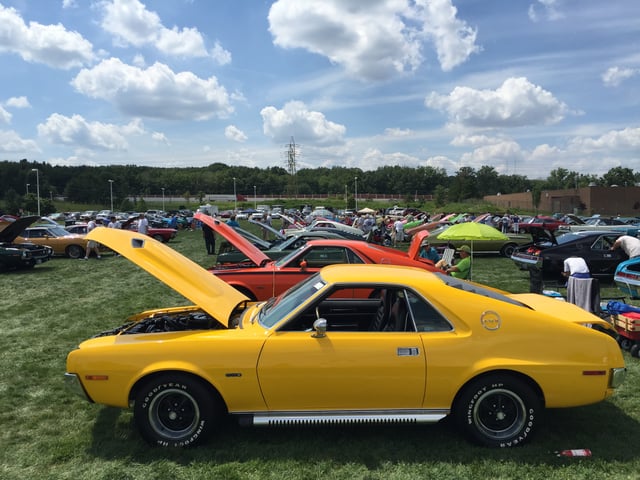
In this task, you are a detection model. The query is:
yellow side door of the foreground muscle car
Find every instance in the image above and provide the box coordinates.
[258,287,426,411]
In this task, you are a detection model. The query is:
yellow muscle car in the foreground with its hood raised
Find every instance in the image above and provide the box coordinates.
[65,228,626,447]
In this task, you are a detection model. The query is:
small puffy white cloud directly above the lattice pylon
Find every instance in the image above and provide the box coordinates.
[260,101,346,145]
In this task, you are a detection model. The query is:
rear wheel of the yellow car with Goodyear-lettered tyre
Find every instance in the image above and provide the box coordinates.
[453,375,542,448]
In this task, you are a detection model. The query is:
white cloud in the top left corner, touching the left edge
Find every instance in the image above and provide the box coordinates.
[0,4,94,70]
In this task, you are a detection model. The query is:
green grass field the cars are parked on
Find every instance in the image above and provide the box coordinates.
[0,226,640,480]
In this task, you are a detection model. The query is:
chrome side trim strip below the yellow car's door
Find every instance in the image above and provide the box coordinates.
[242,409,449,425]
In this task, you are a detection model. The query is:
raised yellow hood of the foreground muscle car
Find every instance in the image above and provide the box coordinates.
[86,227,249,327]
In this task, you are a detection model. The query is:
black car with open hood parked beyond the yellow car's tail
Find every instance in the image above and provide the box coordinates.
[511,230,628,281]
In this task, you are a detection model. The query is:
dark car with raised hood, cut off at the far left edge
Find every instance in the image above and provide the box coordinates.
[0,216,53,271]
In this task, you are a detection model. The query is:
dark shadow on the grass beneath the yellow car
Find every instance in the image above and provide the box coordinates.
[88,402,640,470]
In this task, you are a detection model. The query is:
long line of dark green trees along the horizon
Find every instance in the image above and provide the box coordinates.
[0,159,640,211]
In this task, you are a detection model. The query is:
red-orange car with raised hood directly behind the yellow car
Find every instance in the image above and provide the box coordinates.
[195,213,438,300]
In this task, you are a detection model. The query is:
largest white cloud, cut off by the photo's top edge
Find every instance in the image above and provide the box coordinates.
[269,0,478,80]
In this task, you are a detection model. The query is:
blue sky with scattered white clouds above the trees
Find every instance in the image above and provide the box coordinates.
[0,0,640,178]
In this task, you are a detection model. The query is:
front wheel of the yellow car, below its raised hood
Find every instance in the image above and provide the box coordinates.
[134,374,222,448]
